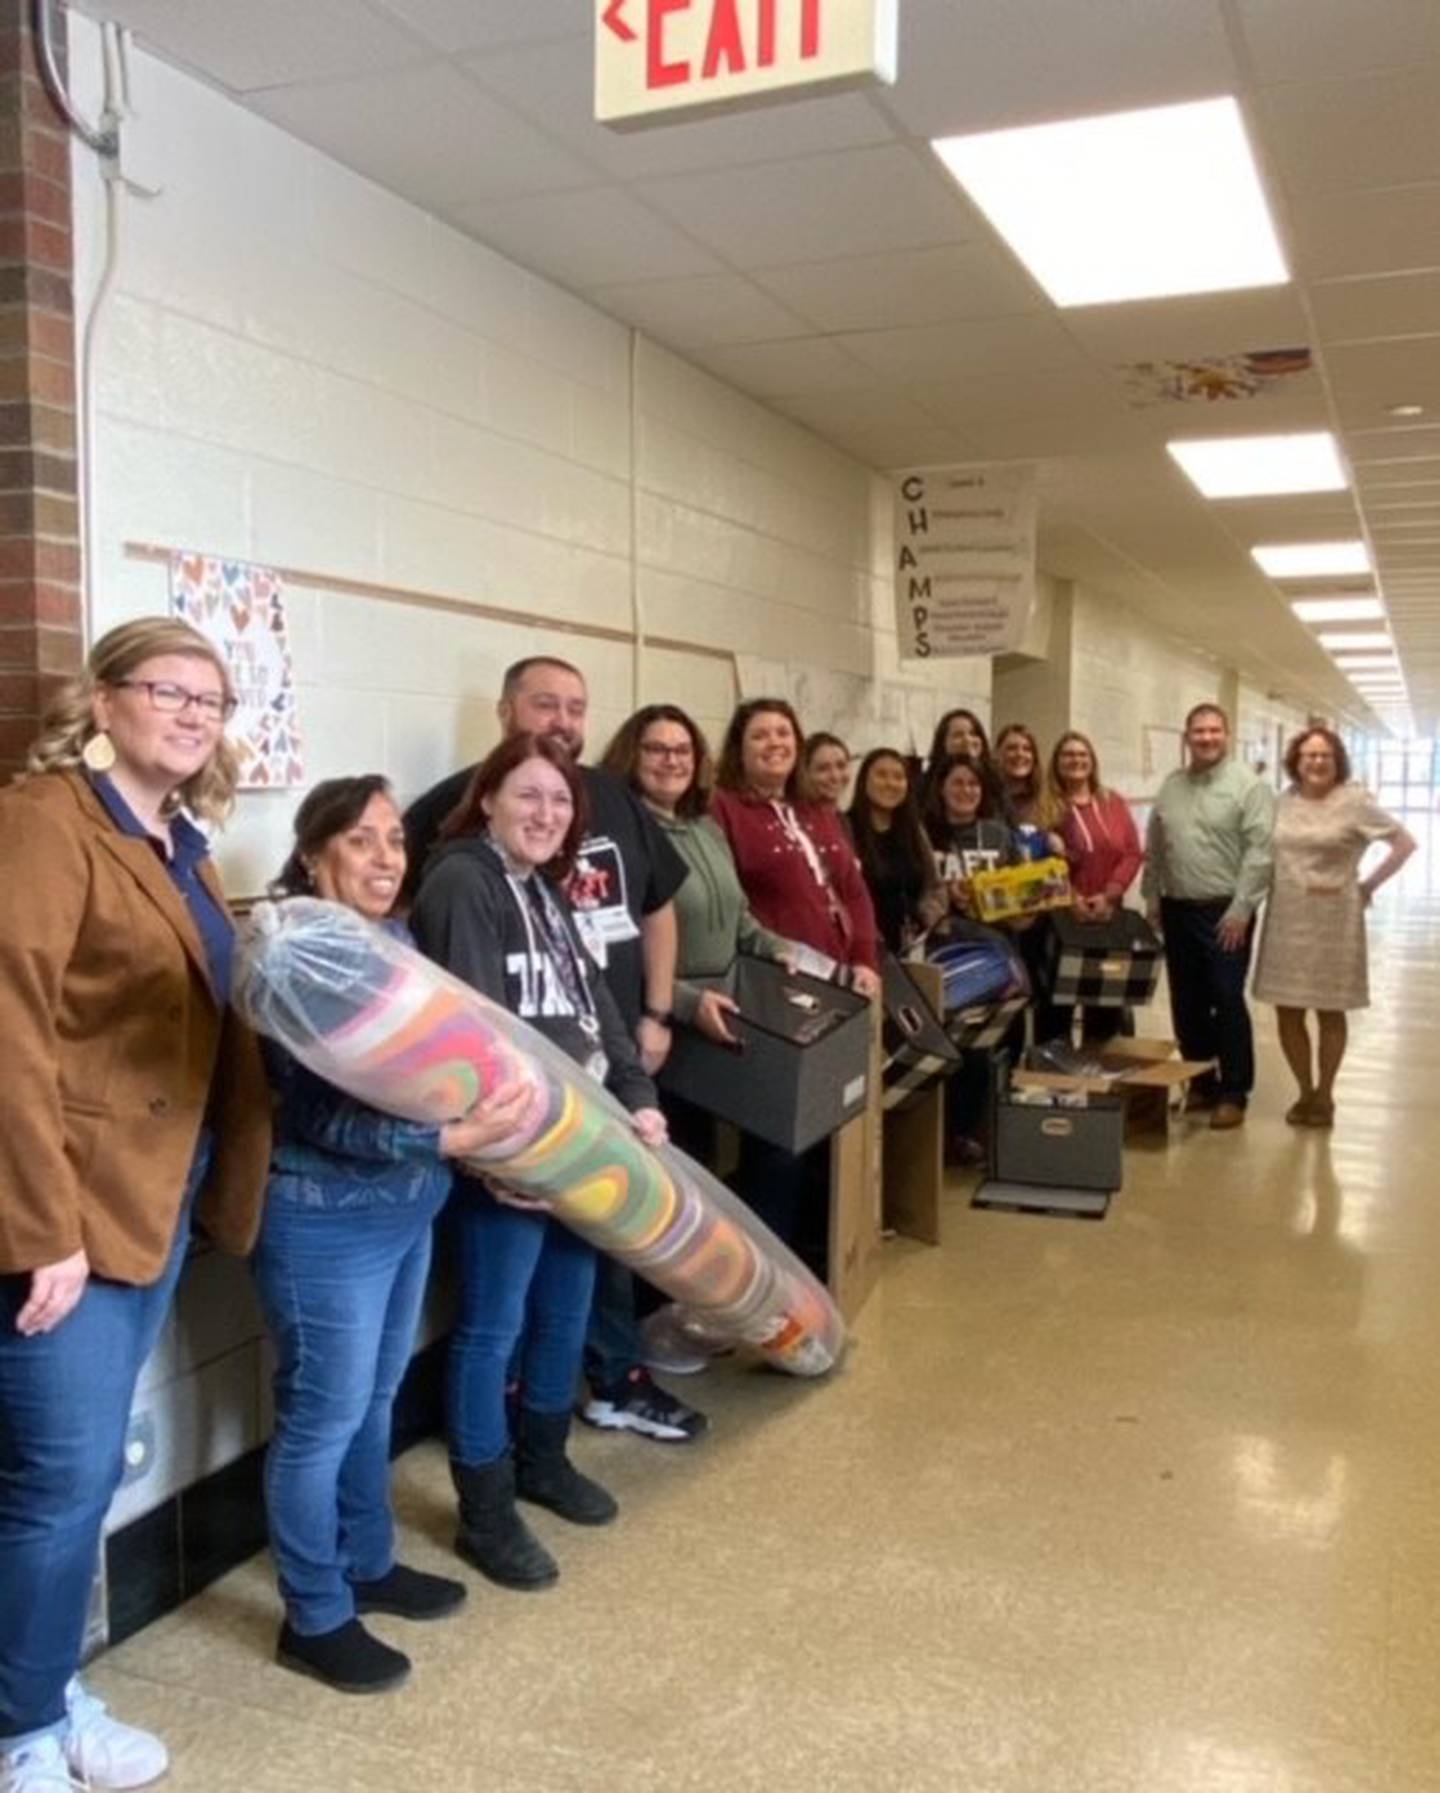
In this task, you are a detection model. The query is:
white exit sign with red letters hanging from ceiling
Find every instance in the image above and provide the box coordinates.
[595,0,898,127]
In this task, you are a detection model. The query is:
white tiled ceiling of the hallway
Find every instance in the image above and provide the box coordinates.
[73,0,1440,730]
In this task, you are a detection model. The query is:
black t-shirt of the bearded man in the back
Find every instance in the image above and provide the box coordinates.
[405,766,689,1033]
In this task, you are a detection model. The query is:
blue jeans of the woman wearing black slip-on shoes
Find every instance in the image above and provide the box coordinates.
[253,1183,438,1637]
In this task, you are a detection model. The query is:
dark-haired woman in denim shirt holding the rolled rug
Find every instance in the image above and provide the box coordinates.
[253,773,529,1693]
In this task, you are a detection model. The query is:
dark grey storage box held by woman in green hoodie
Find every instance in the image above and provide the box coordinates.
[658,957,872,1153]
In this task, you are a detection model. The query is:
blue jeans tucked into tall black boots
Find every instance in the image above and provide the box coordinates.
[447,1178,595,1468]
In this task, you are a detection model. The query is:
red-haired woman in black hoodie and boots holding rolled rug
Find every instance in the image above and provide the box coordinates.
[411,733,665,1589]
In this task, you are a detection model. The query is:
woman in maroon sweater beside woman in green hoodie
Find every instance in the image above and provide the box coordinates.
[710,697,880,997]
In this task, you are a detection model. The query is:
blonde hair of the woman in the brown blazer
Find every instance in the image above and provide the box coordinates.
[16,617,240,821]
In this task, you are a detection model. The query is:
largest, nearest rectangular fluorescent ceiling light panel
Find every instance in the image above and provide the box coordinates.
[933,97,1289,305]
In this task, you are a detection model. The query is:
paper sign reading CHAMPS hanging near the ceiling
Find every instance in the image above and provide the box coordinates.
[895,464,1037,660]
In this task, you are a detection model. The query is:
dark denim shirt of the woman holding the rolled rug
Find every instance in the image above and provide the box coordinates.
[262,922,452,1212]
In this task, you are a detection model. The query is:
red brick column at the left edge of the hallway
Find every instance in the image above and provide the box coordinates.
[0,0,82,780]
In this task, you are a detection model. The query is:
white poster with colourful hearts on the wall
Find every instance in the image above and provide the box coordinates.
[170,554,305,791]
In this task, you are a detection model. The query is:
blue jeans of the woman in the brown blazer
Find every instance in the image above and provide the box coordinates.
[0,1183,197,1745]
